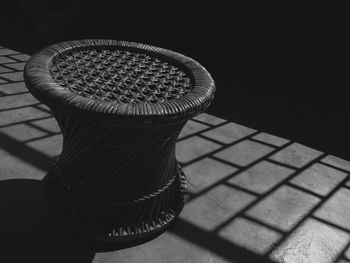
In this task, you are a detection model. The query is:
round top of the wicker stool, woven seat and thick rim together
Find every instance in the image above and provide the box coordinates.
[25,40,215,124]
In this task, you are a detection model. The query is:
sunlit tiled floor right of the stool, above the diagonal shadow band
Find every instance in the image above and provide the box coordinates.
[177,114,350,262]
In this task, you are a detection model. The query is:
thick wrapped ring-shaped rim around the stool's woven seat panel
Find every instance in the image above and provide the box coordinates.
[24,39,216,122]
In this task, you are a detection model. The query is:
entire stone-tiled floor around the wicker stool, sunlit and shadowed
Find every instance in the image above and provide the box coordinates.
[0,48,350,263]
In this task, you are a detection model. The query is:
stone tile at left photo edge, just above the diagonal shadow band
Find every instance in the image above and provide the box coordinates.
[0,123,47,141]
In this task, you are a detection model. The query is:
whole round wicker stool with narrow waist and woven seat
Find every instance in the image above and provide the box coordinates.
[24,40,215,242]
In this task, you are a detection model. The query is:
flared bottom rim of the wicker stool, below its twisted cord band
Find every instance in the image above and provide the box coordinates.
[43,165,187,244]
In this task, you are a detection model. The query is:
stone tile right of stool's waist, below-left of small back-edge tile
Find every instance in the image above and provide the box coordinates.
[214,140,274,166]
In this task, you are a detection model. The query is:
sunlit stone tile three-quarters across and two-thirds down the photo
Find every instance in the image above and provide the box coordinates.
[228,161,294,194]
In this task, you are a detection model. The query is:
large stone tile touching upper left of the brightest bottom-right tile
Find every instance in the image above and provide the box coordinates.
[246,186,320,231]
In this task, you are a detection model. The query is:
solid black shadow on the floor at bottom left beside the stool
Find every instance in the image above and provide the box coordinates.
[0,179,95,263]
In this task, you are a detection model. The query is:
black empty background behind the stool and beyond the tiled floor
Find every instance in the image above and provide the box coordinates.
[0,0,350,160]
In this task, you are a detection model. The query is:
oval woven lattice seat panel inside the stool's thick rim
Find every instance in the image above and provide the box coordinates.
[50,48,193,104]
